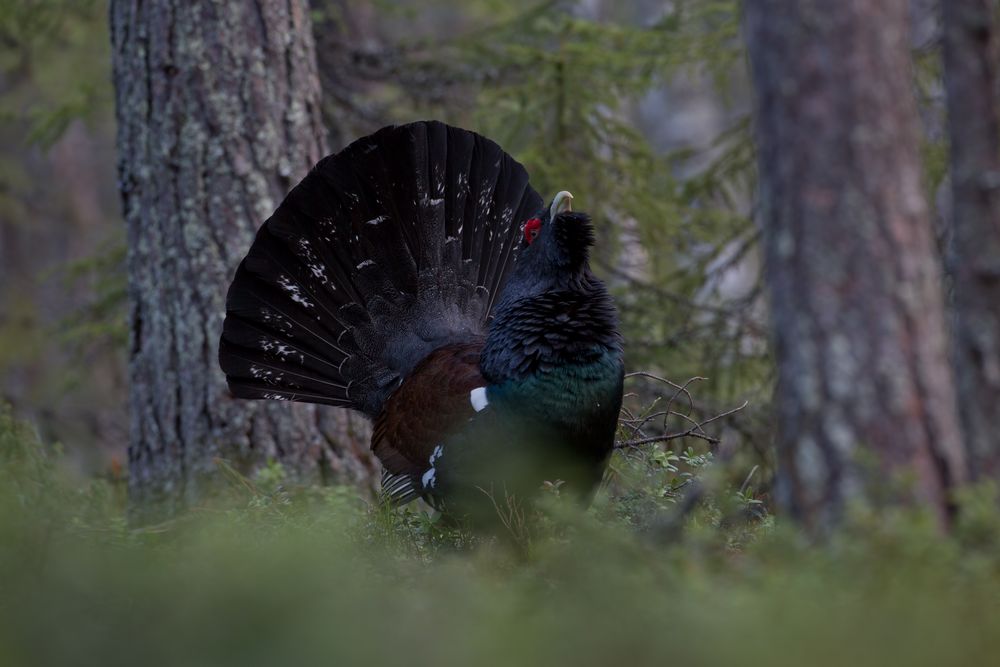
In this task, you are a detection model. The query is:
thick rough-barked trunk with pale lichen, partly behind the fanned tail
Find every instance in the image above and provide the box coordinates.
[111,0,370,512]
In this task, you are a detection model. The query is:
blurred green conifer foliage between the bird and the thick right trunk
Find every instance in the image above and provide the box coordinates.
[321,0,770,402]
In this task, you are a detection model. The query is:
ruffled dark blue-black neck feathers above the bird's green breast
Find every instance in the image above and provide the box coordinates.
[480,271,622,384]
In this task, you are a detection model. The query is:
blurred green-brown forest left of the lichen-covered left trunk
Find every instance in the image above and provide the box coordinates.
[0,0,127,462]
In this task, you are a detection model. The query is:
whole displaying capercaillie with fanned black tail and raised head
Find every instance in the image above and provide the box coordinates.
[219,122,623,516]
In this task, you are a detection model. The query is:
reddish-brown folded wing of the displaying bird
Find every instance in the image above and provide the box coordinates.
[372,339,486,479]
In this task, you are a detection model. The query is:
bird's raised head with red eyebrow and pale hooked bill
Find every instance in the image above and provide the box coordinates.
[510,191,594,291]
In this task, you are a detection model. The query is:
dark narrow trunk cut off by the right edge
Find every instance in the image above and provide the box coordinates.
[941,0,1000,479]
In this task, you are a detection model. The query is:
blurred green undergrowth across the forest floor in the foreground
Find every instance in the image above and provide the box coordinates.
[0,402,1000,667]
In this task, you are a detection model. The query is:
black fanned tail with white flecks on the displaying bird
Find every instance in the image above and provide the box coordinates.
[219,122,542,416]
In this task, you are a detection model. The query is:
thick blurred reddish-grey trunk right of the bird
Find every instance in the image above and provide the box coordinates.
[745,0,965,530]
